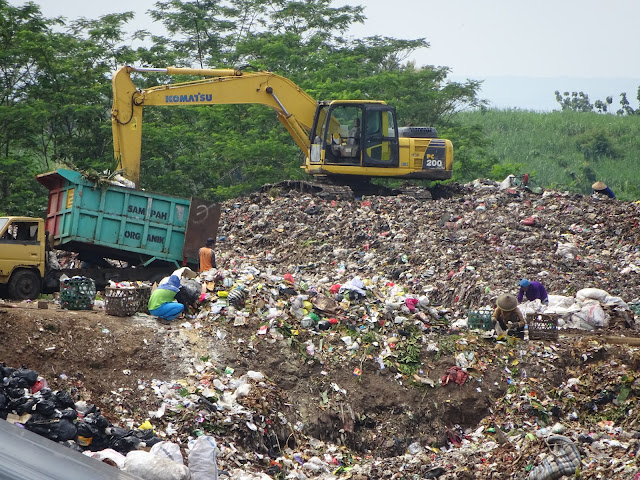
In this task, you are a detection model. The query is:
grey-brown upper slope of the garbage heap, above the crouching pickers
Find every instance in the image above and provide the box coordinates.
[216,181,640,309]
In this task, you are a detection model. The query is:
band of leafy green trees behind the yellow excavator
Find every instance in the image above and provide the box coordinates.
[0,0,482,205]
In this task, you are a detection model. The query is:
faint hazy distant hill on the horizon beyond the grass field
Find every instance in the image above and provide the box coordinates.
[451,75,640,112]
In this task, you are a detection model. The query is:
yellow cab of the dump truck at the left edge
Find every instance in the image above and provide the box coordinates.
[0,217,46,300]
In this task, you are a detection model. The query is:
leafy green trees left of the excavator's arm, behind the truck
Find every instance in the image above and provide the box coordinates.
[0,0,142,214]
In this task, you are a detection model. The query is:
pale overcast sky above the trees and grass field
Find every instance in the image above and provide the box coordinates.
[10,0,640,109]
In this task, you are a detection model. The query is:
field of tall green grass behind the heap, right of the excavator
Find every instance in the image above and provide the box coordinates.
[454,110,640,200]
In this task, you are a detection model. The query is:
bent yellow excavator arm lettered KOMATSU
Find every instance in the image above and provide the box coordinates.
[111,66,318,186]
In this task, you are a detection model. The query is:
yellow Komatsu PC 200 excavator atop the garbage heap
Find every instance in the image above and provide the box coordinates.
[111,66,453,195]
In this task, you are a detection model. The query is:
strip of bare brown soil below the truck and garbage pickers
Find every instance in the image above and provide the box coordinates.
[0,302,504,455]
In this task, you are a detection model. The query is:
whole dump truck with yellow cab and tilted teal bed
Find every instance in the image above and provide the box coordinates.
[0,169,220,299]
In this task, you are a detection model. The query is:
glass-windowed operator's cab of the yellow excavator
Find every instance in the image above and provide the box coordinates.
[310,101,398,167]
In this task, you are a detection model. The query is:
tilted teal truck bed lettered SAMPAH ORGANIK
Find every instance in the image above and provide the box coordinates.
[37,169,220,265]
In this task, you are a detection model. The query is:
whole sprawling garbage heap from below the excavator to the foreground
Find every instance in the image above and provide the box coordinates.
[5,181,640,480]
